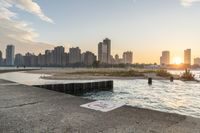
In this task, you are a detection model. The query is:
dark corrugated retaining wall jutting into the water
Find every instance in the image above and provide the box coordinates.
[34,81,113,96]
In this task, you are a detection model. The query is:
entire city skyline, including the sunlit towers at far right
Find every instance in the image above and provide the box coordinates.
[0,42,200,67]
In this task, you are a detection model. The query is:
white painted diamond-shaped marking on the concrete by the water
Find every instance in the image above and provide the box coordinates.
[81,100,125,112]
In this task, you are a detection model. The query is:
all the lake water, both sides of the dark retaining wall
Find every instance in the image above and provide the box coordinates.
[0,71,200,118]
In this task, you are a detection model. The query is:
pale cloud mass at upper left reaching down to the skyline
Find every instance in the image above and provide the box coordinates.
[0,0,53,54]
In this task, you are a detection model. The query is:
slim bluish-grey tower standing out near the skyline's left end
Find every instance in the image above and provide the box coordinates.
[6,45,15,66]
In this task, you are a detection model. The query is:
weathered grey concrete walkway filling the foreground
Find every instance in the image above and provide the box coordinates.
[0,80,200,133]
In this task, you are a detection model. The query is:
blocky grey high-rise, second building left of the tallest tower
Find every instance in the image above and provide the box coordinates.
[69,47,81,64]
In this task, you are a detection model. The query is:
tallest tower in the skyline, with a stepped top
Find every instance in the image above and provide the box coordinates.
[98,38,111,64]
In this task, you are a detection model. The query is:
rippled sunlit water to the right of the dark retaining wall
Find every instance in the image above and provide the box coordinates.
[85,79,200,117]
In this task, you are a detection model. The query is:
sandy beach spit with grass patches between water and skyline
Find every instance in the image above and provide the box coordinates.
[27,68,178,80]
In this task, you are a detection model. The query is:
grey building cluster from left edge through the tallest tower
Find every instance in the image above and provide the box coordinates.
[0,38,133,67]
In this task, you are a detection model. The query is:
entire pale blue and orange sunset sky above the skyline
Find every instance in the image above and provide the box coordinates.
[0,0,200,63]
